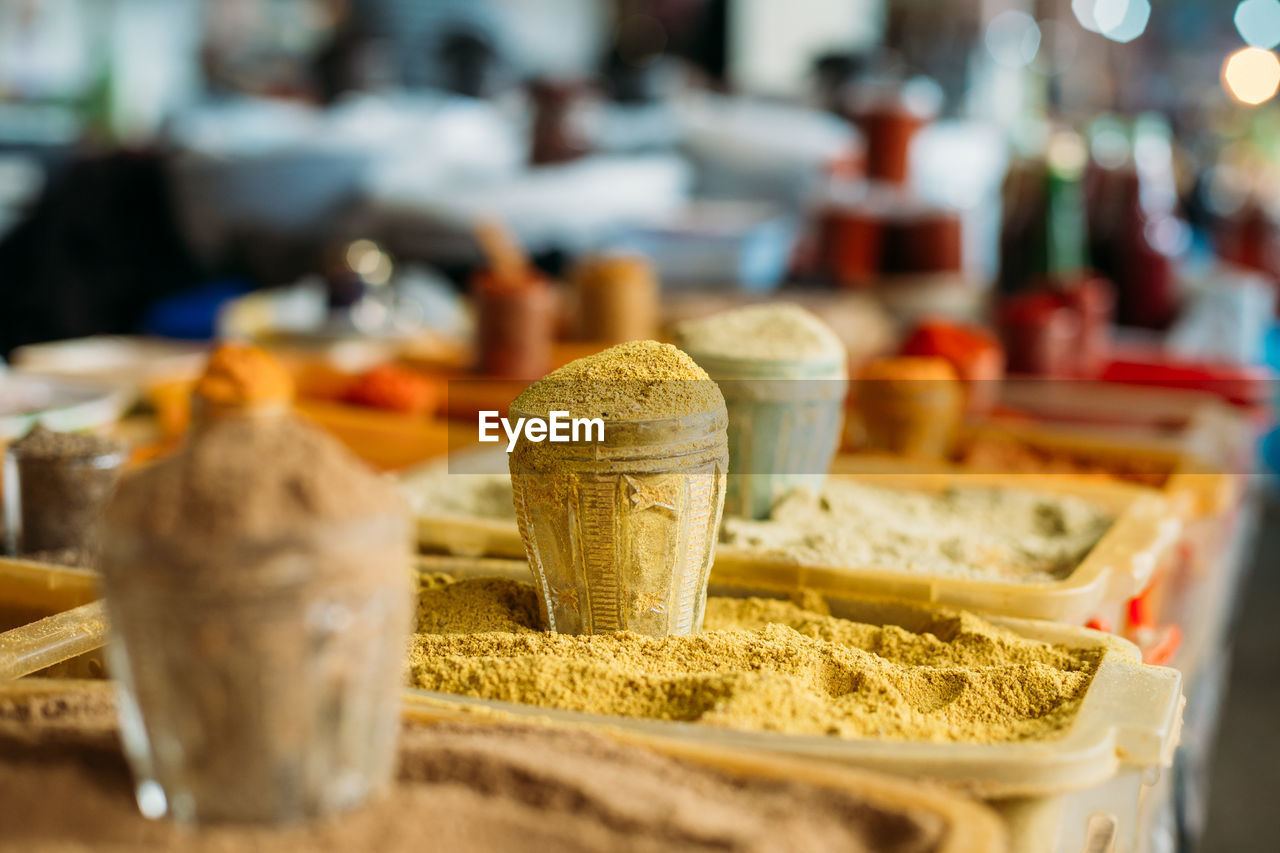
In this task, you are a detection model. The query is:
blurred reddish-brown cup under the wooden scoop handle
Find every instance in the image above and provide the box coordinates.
[472,270,556,379]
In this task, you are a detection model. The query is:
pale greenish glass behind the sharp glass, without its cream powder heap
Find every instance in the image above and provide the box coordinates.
[681,343,849,519]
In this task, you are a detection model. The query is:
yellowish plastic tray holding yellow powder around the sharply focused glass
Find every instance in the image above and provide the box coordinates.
[407,561,1183,853]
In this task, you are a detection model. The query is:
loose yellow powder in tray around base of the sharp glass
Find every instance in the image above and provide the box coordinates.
[410,578,1102,743]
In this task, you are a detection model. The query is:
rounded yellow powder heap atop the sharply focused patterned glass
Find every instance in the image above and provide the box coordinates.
[511,341,724,420]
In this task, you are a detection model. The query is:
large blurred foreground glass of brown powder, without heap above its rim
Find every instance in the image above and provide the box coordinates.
[102,516,412,825]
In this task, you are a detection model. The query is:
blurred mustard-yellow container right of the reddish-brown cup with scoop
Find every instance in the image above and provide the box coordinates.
[573,255,658,343]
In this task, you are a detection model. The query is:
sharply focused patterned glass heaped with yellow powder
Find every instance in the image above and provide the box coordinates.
[509,341,728,637]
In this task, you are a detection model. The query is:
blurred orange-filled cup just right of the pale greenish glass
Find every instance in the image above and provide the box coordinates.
[858,356,964,459]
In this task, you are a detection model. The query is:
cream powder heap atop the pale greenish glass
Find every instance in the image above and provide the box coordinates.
[677,304,845,362]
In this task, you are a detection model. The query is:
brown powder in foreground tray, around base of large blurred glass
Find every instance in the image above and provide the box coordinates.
[0,692,950,853]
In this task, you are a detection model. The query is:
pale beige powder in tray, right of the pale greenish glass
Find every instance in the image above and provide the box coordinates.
[721,478,1115,583]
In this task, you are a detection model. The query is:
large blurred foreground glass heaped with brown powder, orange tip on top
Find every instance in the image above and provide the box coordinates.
[101,346,412,824]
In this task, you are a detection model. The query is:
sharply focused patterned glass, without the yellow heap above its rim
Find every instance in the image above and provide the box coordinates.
[509,409,728,637]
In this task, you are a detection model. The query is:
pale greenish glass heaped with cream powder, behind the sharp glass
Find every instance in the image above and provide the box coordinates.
[677,305,849,519]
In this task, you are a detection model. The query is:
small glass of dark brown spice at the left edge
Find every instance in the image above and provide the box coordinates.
[4,427,128,553]
